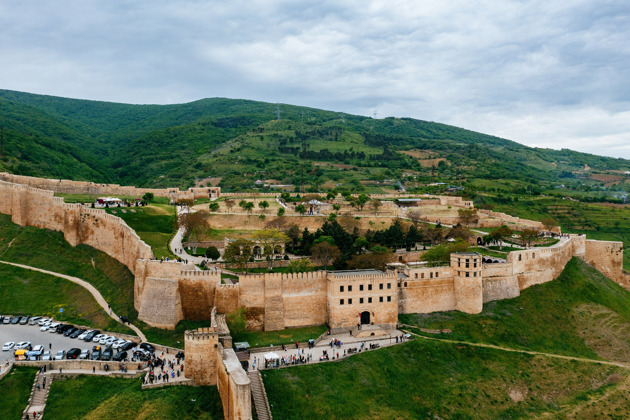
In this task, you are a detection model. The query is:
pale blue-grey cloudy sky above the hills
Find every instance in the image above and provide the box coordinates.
[0,0,630,159]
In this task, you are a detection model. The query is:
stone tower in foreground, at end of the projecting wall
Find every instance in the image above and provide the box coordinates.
[184,328,219,386]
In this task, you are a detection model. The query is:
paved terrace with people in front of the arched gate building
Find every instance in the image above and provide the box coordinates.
[249,330,405,370]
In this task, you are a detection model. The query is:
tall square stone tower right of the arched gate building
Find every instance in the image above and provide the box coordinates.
[451,252,483,314]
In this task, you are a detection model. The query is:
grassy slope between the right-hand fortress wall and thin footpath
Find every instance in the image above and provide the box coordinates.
[400,258,630,361]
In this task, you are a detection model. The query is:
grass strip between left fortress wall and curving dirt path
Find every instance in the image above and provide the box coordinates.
[0,214,138,321]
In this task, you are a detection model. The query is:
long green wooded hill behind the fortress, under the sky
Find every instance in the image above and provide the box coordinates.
[0,90,630,193]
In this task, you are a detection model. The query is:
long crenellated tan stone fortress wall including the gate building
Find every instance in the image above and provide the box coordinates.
[0,172,629,330]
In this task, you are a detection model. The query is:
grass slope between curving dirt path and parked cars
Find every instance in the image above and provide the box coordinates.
[0,264,135,335]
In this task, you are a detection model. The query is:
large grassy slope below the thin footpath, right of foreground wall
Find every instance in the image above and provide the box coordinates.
[261,340,630,420]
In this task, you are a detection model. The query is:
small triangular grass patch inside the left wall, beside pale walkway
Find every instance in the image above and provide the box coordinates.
[106,204,177,258]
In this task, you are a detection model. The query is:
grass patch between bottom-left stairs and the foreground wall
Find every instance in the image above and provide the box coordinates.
[46,375,223,420]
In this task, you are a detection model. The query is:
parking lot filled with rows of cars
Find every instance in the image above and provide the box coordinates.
[0,316,131,362]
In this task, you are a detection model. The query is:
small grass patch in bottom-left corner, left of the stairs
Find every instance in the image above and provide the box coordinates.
[0,368,37,419]
